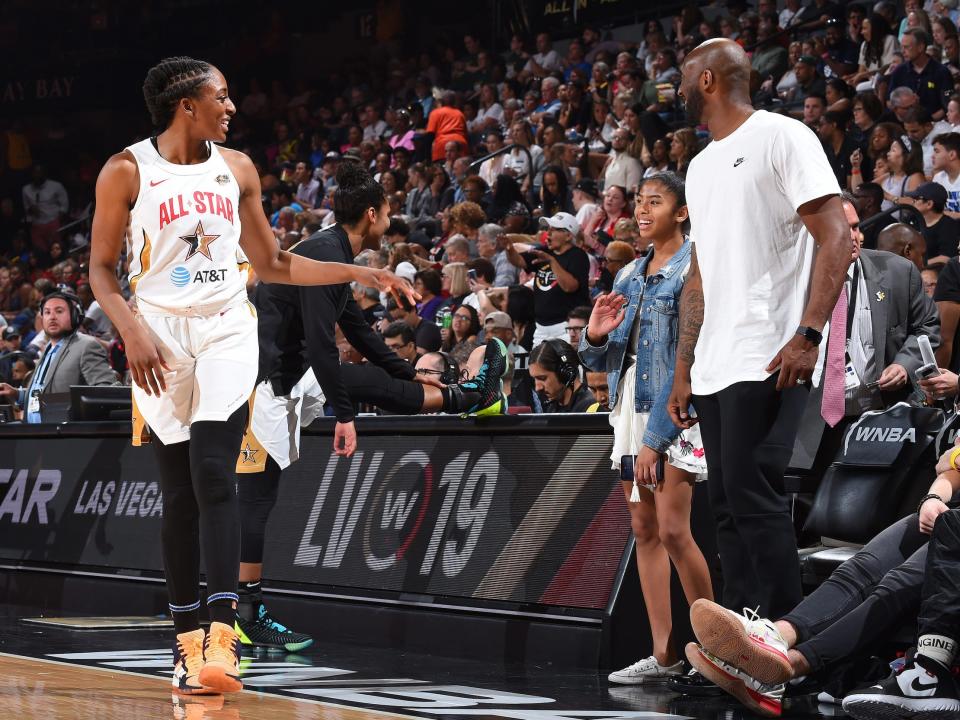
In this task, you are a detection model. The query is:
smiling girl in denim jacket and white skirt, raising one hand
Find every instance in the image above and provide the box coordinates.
[580,173,713,684]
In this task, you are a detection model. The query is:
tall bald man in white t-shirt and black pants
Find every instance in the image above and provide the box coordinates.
[668,40,852,622]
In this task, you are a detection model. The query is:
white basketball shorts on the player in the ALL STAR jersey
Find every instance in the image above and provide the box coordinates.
[133,300,260,445]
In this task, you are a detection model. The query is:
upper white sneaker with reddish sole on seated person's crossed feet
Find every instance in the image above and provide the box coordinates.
[690,599,793,685]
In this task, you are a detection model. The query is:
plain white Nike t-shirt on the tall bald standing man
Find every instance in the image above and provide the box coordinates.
[687,110,840,395]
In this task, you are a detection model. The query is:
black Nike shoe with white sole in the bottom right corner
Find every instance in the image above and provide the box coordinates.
[843,655,960,720]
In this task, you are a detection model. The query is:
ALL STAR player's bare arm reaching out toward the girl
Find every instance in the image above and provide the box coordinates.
[222,150,415,302]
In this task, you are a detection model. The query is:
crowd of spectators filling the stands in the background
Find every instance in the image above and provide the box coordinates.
[0,0,960,422]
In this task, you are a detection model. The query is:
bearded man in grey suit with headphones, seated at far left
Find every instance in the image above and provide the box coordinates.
[0,290,120,423]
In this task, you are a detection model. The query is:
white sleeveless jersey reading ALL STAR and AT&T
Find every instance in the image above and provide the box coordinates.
[127,138,247,315]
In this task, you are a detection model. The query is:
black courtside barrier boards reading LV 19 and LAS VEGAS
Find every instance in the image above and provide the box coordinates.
[0,418,630,610]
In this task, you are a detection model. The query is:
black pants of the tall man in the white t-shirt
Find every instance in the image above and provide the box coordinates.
[693,375,808,617]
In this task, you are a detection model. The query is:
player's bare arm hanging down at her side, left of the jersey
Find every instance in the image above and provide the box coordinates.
[90,153,169,395]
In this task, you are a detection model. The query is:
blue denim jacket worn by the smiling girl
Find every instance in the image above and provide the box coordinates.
[579,238,692,452]
